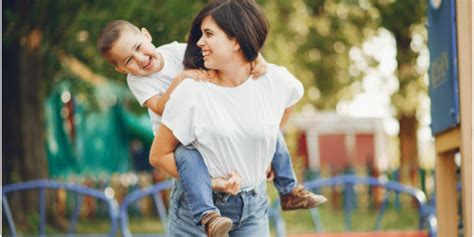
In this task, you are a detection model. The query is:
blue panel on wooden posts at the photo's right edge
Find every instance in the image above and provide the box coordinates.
[428,0,473,237]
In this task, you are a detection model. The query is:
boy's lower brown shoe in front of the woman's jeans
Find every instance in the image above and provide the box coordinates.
[201,212,232,237]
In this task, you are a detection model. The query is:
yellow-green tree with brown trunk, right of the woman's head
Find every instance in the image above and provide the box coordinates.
[262,0,427,184]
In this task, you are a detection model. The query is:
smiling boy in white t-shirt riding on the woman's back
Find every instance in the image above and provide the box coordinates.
[97,20,326,236]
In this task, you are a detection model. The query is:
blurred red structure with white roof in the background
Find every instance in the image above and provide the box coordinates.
[297,113,388,173]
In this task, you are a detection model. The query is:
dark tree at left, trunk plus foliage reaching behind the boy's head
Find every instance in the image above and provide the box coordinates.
[2,0,205,227]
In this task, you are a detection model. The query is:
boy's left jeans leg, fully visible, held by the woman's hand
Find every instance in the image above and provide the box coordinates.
[175,145,220,224]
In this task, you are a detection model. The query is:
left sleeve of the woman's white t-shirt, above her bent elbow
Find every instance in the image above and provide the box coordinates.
[161,80,197,146]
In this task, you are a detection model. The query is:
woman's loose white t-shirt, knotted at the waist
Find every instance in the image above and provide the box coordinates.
[162,64,304,188]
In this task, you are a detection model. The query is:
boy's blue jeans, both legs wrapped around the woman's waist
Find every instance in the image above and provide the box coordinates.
[175,132,296,224]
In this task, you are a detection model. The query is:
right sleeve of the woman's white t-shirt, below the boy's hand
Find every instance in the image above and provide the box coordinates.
[275,66,304,108]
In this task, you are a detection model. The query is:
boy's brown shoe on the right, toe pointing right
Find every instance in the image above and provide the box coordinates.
[280,185,327,211]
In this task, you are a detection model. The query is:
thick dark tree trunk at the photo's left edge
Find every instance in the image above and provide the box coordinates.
[2,30,48,224]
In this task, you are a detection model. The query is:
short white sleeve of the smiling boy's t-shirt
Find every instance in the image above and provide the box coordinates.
[127,74,162,106]
